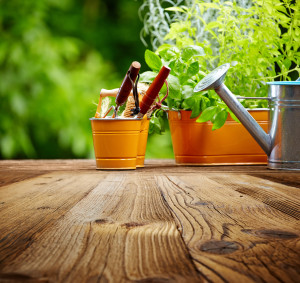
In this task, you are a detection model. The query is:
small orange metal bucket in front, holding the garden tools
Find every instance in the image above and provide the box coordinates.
[90,118,142,169]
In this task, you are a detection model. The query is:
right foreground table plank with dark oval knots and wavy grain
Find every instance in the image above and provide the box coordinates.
[156,173,300,282]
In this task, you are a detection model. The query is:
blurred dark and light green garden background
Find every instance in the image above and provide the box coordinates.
[0,0,173,159]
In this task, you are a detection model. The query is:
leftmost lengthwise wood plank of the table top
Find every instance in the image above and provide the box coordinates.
[0,172,102,268]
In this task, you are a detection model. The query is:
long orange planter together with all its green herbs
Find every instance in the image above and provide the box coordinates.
[141,0,300,164]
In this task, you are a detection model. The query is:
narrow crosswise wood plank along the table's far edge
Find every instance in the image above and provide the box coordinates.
[0,159,300,185]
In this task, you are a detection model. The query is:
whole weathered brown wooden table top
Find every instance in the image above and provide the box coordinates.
[0,160,300,283]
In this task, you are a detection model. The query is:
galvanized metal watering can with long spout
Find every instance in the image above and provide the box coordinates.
[194,63,300,170]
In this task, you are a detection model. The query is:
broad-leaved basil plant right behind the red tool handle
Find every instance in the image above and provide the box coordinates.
[140,44,235,132]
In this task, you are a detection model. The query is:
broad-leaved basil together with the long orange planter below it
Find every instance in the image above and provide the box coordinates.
[141,45,268,164]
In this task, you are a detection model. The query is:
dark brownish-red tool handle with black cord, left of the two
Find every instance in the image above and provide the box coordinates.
[116,61,141,106]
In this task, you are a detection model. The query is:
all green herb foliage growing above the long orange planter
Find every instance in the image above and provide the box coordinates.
[141,0,300,133]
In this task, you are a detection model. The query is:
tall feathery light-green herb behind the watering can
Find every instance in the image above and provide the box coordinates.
[165,0,300,96]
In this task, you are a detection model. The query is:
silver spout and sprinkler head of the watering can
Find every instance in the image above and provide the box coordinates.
[194,64,272,156]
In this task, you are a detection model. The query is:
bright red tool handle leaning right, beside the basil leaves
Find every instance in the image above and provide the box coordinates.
[139,66,171,116]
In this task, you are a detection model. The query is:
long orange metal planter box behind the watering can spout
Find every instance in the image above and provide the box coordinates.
[169,110,268,165]
